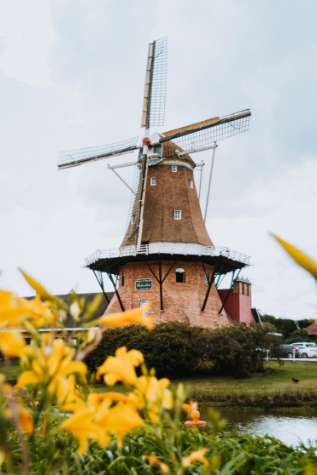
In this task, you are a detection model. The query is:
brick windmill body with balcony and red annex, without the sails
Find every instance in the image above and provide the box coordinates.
[87,142,253,327]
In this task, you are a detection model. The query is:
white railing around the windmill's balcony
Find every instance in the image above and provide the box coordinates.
[86,242,250,266]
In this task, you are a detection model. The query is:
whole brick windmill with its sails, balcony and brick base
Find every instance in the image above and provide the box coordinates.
[59,40,251,327]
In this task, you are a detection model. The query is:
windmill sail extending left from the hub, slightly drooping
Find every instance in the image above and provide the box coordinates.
[58,137,139,169]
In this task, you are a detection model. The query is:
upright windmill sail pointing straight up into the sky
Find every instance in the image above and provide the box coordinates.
[141,38,167,129]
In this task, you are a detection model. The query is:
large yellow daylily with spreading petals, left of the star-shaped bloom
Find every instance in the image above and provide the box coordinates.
[17,338,87,406]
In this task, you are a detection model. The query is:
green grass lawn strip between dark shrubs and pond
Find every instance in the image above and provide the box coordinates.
[178,362,317,405]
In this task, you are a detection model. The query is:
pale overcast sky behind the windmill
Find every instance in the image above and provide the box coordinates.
[0,0,317,318]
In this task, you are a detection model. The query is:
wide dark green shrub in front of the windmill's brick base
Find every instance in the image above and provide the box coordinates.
[86,322,274,378]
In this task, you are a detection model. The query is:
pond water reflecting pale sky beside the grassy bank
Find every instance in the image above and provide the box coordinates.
[202,405,317,447]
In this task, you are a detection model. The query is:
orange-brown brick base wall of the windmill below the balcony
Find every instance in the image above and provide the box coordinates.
[107,261,231,328]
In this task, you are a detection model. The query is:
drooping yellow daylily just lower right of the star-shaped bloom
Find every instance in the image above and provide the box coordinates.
[134,376,173,423]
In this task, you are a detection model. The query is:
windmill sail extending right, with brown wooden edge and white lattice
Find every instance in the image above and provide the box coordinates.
[160,109,251,153]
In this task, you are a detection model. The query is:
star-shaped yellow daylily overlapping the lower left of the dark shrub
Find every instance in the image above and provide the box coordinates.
[97,347,143,386]
